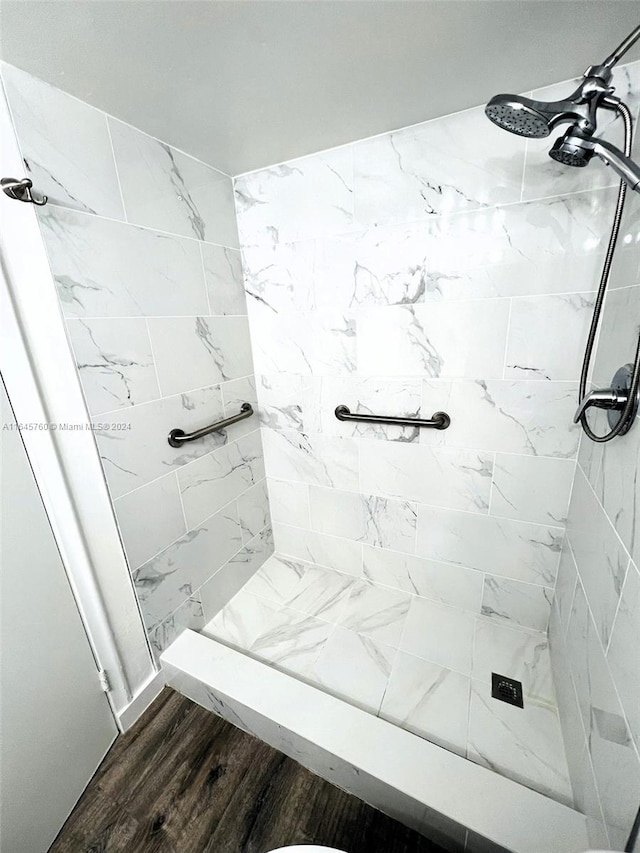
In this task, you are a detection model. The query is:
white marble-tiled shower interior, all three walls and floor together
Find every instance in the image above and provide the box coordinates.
[2,50,640,849]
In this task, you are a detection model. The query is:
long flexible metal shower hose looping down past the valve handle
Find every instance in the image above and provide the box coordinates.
[580,102,640,444]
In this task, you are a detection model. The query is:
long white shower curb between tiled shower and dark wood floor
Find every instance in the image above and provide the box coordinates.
[161,630,589,853]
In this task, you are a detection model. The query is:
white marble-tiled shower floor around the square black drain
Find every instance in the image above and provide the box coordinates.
[203,554,572,805]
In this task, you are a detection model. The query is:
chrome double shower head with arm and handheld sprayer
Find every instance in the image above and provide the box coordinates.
[485,26,640,192]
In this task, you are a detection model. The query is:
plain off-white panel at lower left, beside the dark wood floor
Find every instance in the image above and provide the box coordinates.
[0,379,118,853]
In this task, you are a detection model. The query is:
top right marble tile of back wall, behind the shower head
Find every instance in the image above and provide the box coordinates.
[523,62,640,198]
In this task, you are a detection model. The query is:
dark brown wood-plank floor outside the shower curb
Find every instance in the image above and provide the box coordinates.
[50,689,442,853]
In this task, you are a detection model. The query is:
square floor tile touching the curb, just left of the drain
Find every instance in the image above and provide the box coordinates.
[380,652,469,757]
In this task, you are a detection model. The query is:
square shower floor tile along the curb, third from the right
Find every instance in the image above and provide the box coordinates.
[311,627,396,714]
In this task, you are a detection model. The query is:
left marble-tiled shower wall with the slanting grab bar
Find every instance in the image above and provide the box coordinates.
[1,64,273,653]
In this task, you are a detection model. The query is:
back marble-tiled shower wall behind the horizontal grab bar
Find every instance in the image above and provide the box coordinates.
[235,63,640,630]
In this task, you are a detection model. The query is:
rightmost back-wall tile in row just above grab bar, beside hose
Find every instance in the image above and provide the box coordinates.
[504,293,595,381]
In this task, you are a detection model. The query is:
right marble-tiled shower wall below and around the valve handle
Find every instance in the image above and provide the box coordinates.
[550,181,640,850]
